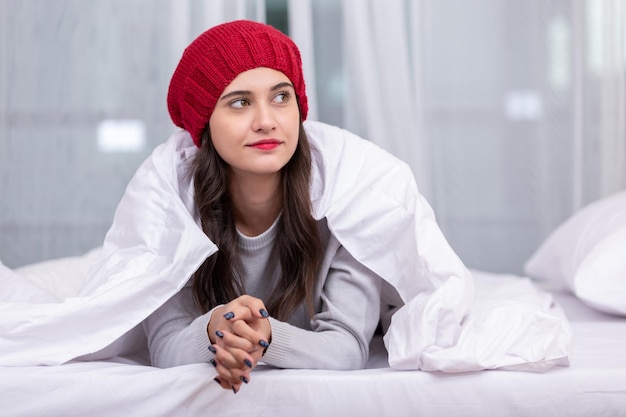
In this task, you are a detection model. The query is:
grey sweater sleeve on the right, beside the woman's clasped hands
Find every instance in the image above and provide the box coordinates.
[263,247,382,370]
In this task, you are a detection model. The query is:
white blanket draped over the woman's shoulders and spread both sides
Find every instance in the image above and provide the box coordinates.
[0,122,571,372]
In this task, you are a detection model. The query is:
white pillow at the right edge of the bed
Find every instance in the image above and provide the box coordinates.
[524,191,626,315]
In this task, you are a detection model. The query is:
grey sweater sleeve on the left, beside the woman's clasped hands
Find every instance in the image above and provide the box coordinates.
[143,285,214,368]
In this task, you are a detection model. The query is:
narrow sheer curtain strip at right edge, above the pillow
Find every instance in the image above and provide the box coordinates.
[570,0,626,206]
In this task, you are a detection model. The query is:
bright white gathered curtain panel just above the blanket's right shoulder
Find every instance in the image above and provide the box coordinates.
[343,0,424,190]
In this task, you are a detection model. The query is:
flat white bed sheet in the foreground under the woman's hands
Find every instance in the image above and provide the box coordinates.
[0,272,626,417]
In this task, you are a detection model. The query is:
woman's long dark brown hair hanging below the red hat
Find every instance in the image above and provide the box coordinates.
[192,123,321,320]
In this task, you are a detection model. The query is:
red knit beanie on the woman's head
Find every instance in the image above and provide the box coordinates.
[167,20,308,147]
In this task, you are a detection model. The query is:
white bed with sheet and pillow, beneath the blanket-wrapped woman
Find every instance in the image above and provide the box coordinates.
[0,193,626,417]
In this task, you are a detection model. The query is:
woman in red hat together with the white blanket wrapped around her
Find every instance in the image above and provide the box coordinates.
[0,21,570,380]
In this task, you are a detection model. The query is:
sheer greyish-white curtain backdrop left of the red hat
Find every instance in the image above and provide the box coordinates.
[0,0,270,267]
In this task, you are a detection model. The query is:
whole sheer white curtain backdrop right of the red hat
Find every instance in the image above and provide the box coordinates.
[298,0,626,272]
